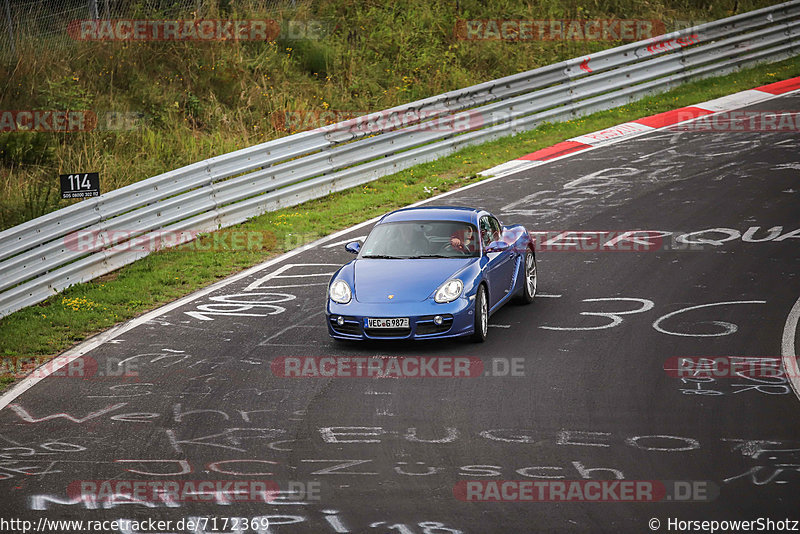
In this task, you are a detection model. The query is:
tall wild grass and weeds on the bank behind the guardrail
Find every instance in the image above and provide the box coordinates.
[0,0,784,229]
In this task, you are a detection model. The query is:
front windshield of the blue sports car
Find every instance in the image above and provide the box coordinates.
[360,221,480,259]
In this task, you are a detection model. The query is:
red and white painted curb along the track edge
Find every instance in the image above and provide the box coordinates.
[478,77,800,176]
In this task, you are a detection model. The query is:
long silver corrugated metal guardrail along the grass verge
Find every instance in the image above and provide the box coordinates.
[0,0,800,317]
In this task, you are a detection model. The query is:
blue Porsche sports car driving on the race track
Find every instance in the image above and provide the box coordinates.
[326,206,536,342]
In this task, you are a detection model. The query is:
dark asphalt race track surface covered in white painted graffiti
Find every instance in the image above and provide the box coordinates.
[0,94,800,534]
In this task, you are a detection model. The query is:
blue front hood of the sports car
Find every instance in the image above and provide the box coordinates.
[353,258,478,303]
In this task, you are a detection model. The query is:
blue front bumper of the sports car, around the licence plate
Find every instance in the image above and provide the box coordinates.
[326,297,475,340]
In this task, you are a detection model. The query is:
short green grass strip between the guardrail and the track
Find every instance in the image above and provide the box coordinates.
[0,58,800,389]
